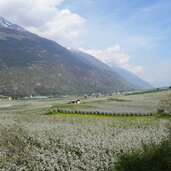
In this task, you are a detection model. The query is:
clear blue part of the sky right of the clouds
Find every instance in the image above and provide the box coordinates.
[61,0,171,86]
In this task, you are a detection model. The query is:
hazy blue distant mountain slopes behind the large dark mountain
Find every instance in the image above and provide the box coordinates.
[71,49,152,90]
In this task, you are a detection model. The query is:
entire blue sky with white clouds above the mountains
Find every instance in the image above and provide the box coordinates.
[0,0,171,87]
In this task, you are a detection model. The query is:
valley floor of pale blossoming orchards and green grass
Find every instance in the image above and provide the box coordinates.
[0,90,171,171]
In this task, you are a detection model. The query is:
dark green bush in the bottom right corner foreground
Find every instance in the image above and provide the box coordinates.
[111,121,171,171]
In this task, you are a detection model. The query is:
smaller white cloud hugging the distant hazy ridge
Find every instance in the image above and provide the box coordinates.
[79,45,143,74]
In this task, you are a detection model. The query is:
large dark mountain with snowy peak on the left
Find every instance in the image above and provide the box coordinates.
[0,17,137,95]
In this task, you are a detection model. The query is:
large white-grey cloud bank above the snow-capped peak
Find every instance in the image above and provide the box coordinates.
[0,0,85,45]
